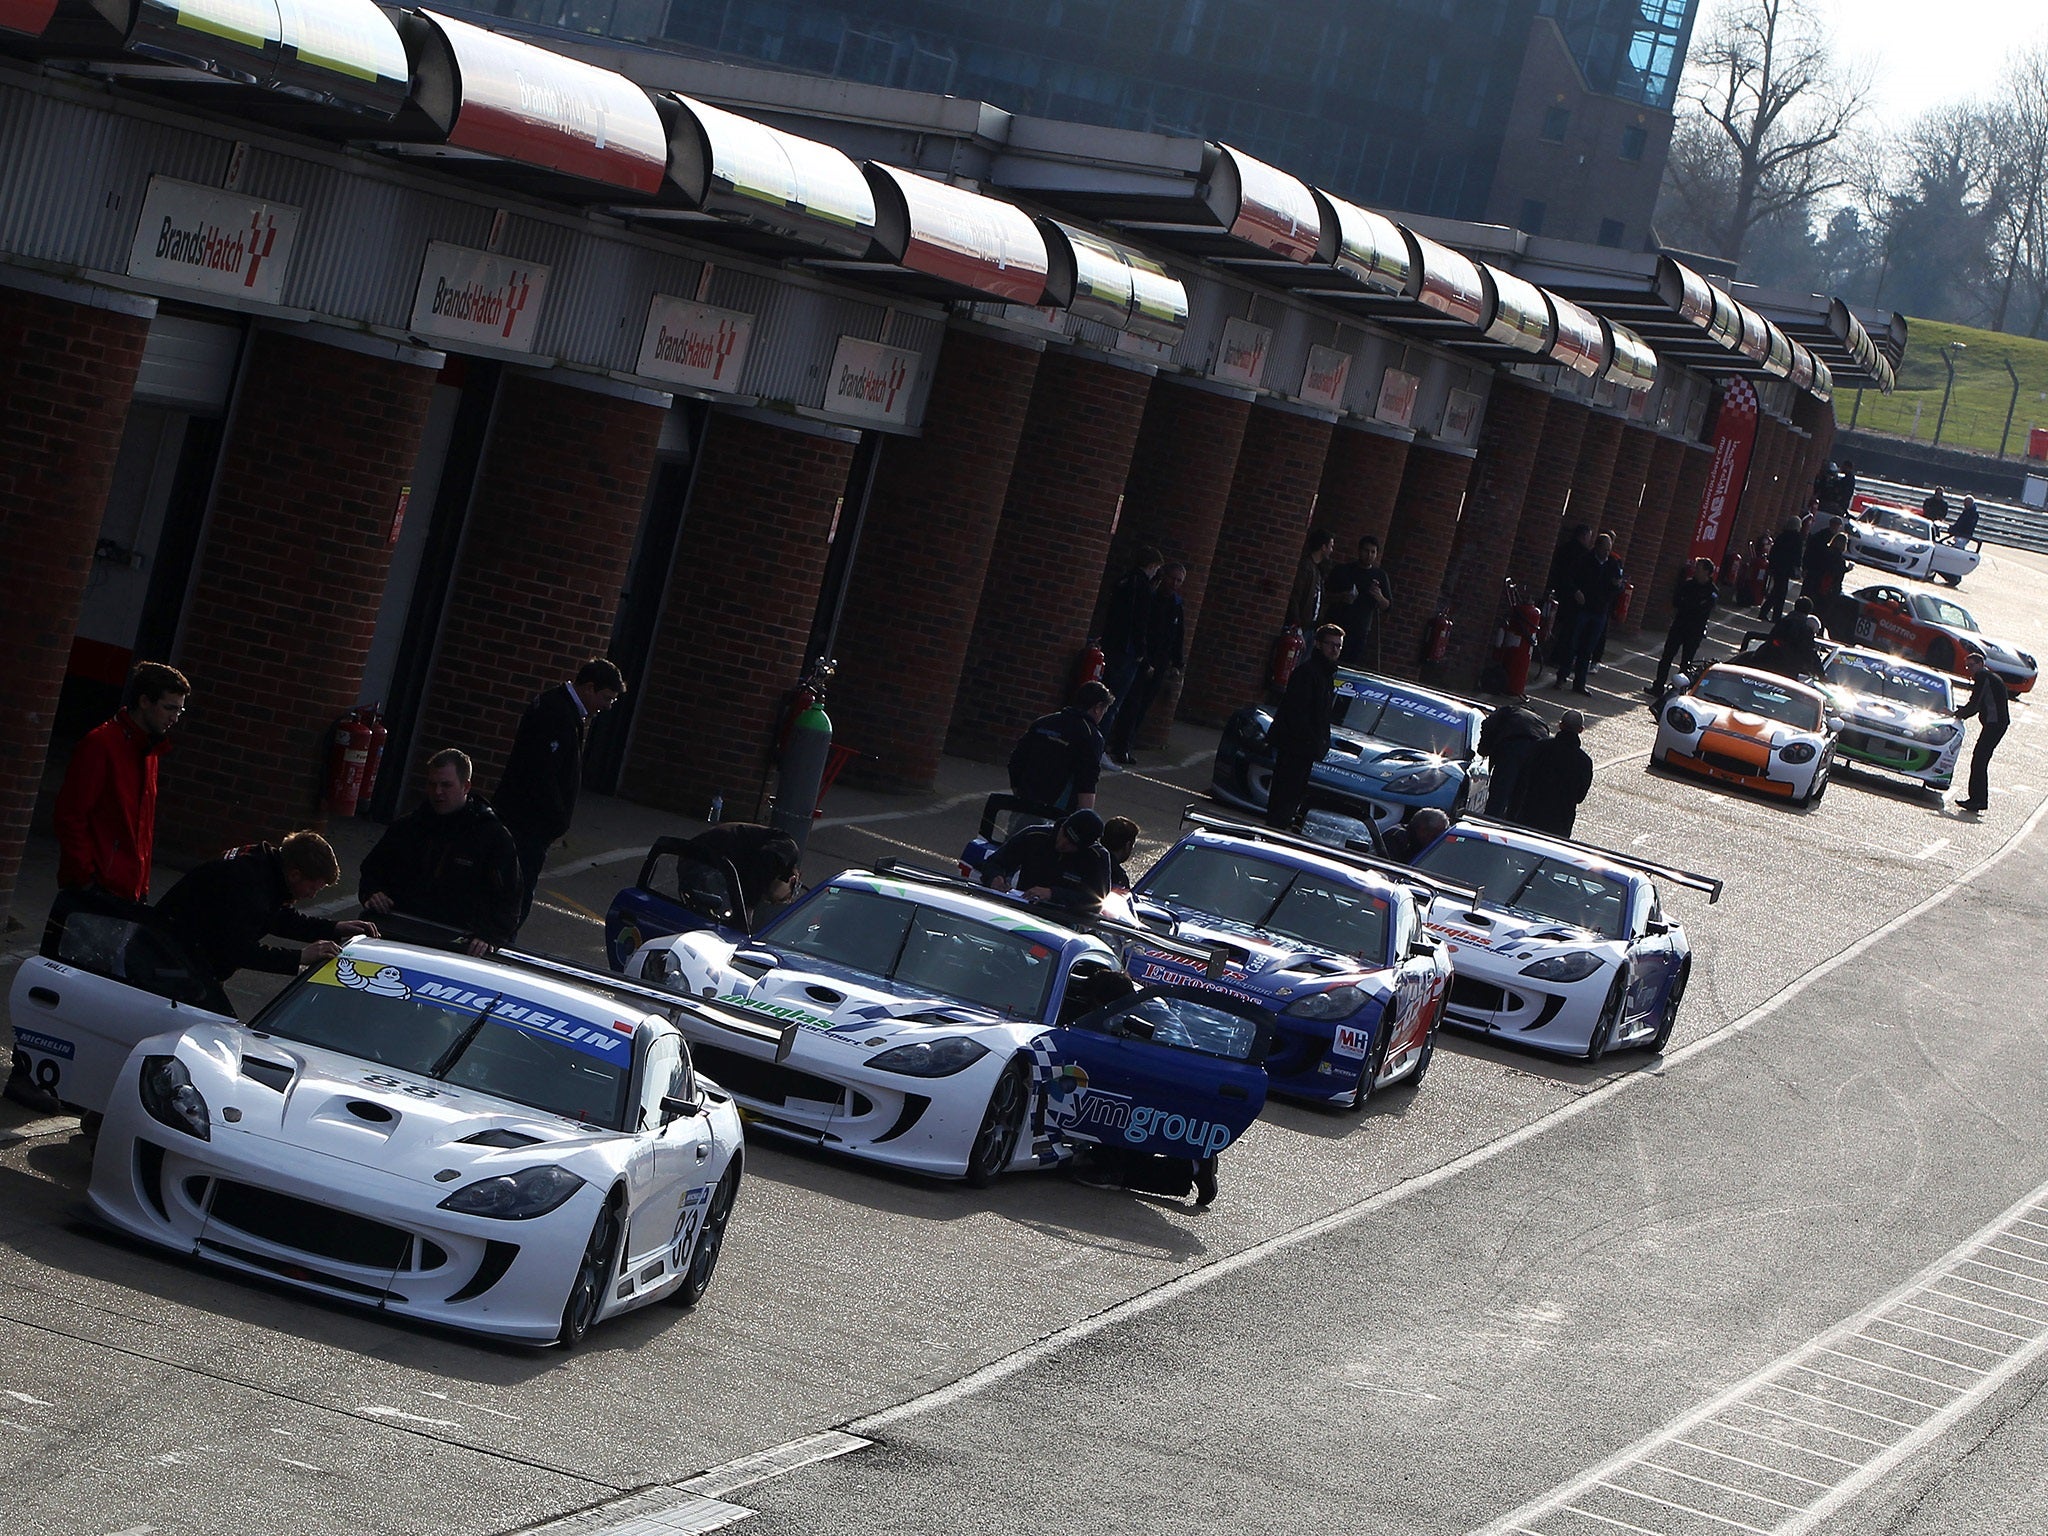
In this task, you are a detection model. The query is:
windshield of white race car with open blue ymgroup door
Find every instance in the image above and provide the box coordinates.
[762,885,1059,1018]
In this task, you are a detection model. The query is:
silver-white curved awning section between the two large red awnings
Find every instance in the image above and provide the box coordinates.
[621,94,874,258]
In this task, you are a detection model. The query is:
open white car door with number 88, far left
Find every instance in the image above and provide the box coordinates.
[8,891,236,1114]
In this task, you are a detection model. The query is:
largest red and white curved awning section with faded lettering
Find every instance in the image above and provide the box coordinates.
[383,10,668,203]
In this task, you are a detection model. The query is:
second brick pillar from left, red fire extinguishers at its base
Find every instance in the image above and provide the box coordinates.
[158,330,442,858]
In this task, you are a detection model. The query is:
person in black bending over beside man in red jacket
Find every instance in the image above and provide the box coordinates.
[156,831,377,981]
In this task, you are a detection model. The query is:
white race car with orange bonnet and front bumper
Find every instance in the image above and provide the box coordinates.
[1651,666,1837,805]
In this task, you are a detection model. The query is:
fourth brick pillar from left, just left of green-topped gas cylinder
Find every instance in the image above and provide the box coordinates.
[618,412,851,821]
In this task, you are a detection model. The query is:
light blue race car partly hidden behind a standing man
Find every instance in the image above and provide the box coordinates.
[1208,668,1487,831]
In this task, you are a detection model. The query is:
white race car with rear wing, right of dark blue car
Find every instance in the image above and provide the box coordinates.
[1415,817,1720,1061]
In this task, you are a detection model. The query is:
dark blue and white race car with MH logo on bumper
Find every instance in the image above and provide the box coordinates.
[1126,811,1473,1110]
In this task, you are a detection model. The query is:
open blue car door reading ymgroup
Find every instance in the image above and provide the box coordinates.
[1032,985,1274,1157]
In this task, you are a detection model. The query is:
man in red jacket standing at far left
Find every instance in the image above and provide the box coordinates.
[57,662,193,901]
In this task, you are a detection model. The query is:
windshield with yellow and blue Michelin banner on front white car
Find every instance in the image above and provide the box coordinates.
[250,961,633,1130]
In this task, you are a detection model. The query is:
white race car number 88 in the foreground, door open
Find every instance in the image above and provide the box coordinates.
[10,913,776,1343]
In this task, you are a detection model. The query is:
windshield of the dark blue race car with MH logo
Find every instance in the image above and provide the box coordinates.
[1139,844,1389,965]
